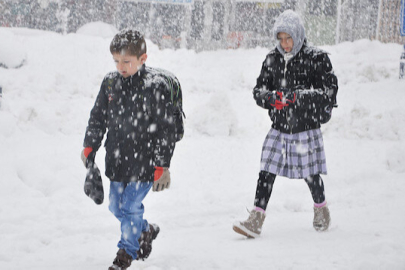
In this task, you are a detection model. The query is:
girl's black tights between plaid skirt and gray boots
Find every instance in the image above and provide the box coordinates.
[255,171,325,210]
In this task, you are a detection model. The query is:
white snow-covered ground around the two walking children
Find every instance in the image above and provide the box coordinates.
[0,24,405,270]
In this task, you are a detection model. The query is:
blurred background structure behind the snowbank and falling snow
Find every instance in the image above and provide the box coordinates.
[0,0,405,51]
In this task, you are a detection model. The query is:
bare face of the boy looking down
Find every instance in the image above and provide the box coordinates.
[113,53,148,78]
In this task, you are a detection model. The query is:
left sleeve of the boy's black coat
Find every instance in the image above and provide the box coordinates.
[83,79,108,152]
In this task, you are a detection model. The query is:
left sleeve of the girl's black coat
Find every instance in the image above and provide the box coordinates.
[253,56,274,109]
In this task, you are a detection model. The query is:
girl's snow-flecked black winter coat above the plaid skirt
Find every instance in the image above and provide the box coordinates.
[253,44,338,133]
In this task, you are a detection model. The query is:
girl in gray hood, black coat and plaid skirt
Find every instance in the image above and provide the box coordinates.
[233,10,338,238]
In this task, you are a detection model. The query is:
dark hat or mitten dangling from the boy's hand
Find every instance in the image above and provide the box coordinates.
[84,162,104,204]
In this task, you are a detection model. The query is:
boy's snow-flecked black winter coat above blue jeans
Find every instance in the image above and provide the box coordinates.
[84,66,175,182]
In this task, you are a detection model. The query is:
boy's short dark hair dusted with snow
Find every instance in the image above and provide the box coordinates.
[110,30,146,58]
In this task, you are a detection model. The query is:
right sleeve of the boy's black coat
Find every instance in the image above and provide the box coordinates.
[150,82,176,167]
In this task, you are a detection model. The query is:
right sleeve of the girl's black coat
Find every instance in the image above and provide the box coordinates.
[296,53,338,107]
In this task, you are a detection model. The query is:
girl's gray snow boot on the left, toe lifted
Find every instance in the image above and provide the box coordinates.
[233,210,266,238]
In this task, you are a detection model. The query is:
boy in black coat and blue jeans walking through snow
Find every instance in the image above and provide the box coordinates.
[82,30,177,270]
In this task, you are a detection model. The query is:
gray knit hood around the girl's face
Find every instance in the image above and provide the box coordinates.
[273,10,305,56]
